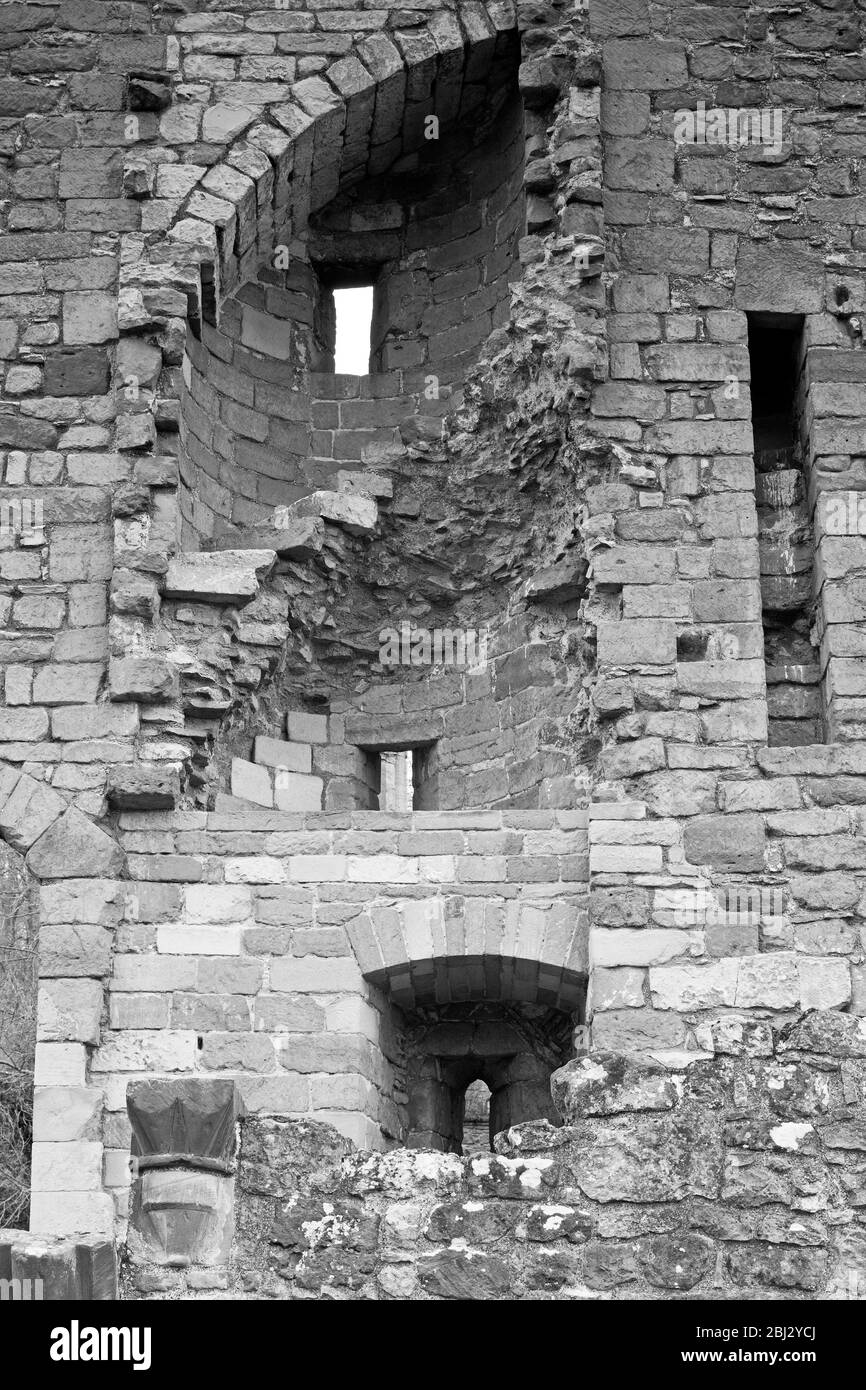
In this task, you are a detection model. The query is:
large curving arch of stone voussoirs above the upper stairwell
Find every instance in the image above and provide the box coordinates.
[158,0,518,331]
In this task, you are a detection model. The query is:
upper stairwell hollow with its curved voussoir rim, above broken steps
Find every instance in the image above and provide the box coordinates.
[172,19,524,550]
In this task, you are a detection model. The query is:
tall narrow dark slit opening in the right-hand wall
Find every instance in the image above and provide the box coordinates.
[748,314,824,746]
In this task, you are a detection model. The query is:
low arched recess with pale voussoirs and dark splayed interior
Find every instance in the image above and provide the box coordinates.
[346,895,587,1152]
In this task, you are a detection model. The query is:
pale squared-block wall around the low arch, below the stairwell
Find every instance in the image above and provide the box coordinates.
[84,810,587,1239]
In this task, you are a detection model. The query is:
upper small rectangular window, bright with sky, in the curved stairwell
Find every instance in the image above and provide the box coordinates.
[316,265,379,377]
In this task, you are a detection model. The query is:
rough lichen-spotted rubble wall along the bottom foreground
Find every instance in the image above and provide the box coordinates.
[124,1013,866,1301]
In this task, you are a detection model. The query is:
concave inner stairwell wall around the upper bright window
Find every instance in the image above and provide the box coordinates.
[179,73,524,549]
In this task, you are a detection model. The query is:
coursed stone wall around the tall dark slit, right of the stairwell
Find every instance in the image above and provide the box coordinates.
[589,7,866,1048]
